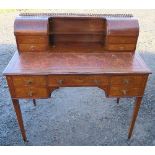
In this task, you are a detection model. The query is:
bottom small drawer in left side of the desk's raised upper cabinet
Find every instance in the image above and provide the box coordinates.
[18,44,47,52]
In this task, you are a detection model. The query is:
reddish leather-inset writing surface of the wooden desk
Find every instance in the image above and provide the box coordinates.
[3,52,151,75]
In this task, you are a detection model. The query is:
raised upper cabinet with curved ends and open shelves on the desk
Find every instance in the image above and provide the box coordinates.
[14,13,139,52]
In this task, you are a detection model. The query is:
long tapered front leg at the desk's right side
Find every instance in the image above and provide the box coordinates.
[128,97,142,139]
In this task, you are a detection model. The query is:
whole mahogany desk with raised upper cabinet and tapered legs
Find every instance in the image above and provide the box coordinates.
[3,13,151,141]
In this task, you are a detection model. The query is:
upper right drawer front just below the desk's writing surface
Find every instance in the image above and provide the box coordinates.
[110,76,146,87]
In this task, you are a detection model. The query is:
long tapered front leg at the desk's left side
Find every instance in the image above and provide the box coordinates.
[12,99,27,141]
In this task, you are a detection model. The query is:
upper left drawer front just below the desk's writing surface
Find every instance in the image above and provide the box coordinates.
[12,76,46,87]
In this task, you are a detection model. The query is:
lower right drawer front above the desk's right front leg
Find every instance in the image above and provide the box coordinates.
[109,86,143,97]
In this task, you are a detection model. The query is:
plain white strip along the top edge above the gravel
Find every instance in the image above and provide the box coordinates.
[0,0,155,9]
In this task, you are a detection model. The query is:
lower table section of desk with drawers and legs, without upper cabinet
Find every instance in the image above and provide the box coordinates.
[4,52,150,140]
